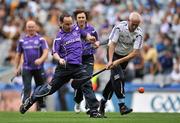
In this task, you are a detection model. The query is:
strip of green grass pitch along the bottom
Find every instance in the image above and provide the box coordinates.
[0,112,180,123]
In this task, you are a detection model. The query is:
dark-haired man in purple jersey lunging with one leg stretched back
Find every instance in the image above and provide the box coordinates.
[20,14,102,118]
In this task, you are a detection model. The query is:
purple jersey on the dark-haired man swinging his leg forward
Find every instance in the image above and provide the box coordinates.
[53,25,87,64]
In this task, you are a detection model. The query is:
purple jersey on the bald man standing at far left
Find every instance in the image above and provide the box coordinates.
[17,34,48,70]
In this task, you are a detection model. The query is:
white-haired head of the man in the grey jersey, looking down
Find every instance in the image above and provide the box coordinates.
[128,12,141,32]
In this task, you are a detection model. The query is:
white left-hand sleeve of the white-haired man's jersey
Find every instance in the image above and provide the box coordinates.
[109,26,121,43]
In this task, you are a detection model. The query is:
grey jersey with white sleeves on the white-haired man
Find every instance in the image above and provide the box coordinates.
[109,21,143,55]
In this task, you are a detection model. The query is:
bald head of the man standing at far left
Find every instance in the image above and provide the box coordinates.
[26,20,37,36]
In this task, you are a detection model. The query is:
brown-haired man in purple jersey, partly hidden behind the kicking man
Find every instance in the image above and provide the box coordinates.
[74,9,99,113]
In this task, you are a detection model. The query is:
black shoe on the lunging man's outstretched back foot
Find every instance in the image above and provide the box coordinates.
[19,98,33,114]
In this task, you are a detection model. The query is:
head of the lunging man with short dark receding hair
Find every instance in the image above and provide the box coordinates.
[59,13,73,32]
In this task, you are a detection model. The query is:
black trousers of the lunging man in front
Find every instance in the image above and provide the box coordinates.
[49,64,99,110]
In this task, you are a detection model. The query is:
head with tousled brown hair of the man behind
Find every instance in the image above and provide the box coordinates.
[74,9,88,26]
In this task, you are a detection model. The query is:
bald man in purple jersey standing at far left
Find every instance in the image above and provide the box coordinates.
[15,20,48,111]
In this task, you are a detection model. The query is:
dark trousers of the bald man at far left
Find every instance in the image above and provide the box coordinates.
[22,69,46,110]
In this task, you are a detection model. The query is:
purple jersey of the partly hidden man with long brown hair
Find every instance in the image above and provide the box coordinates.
[82,24,98,55]
